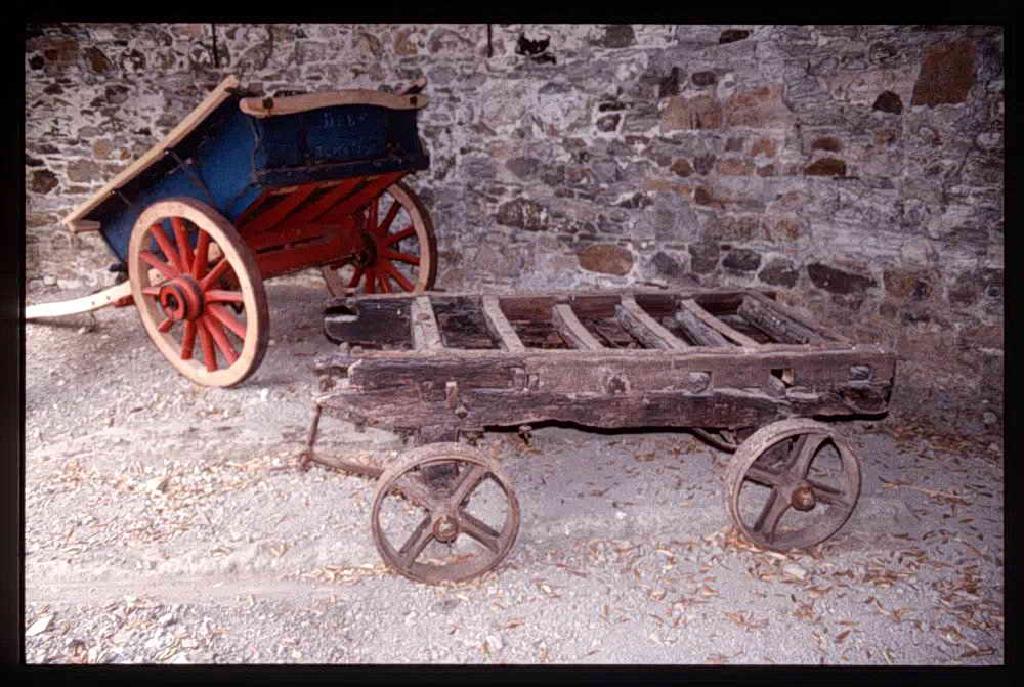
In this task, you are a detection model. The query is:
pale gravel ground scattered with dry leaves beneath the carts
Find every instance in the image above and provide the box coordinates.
[25,276,1005,664]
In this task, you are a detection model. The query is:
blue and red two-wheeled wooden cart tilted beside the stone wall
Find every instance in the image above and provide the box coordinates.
[26,77,436,386]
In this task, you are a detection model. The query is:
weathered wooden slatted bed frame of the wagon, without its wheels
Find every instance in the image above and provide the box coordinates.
[315,290,895,433]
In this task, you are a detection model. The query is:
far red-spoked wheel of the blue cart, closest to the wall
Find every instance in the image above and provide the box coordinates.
[322,181,437,296]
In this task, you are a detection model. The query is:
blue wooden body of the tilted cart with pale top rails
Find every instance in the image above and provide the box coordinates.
[66,78,429,260]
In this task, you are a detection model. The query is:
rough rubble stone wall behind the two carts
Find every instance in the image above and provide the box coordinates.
[26,25,1005,428]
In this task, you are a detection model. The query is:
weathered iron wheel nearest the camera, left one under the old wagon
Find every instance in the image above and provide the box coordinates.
[372,442,519,585]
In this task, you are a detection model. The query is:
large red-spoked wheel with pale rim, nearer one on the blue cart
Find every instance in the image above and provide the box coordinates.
[128,198,269,386]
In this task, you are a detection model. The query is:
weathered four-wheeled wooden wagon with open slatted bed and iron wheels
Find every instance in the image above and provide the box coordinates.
[304,290,895,583]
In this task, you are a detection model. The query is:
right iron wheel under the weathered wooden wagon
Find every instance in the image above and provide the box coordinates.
[726,418,860,552]
